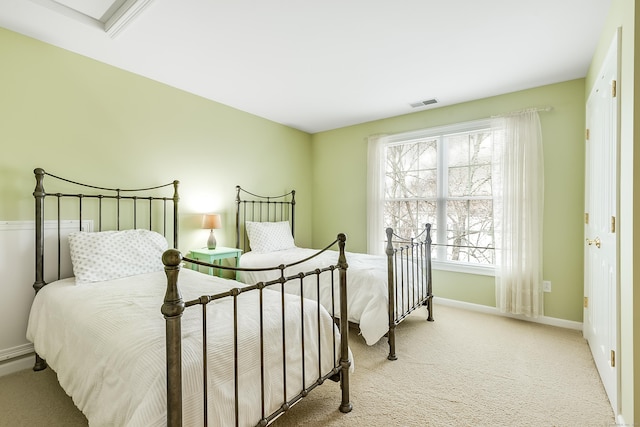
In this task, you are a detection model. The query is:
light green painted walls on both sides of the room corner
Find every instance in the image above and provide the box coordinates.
[0,25,585,321]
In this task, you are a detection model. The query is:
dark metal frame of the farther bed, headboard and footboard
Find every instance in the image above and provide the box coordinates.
[236,185,434,360]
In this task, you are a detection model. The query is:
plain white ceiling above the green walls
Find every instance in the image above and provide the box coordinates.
[0,0,611,133]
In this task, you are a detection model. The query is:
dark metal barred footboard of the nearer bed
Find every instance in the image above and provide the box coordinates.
[161,234,352,426]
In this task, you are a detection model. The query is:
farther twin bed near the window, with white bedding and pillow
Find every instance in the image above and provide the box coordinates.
[236,186,433,360]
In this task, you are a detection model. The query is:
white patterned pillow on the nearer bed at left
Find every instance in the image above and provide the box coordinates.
[69,230,169,284]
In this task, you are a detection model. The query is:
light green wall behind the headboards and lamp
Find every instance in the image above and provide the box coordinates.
[0,29,312,251]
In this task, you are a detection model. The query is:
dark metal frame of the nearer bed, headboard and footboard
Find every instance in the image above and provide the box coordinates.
[33,168,352,426]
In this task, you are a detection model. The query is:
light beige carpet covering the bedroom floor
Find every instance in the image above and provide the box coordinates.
[0,305,615,427]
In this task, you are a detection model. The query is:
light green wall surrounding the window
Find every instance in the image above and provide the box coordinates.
[312,79,585,322]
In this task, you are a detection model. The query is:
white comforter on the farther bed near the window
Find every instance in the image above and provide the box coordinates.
[239,248,389,345]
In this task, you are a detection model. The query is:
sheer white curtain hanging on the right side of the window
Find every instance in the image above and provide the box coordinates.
[493,110,544,317]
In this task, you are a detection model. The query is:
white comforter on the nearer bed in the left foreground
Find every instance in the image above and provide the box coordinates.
[27,269,352,427]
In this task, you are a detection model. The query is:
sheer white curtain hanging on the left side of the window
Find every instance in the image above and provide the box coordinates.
[367,135,386,255]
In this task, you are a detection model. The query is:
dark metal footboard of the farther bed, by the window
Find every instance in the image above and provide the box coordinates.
[385,224,433,360]
